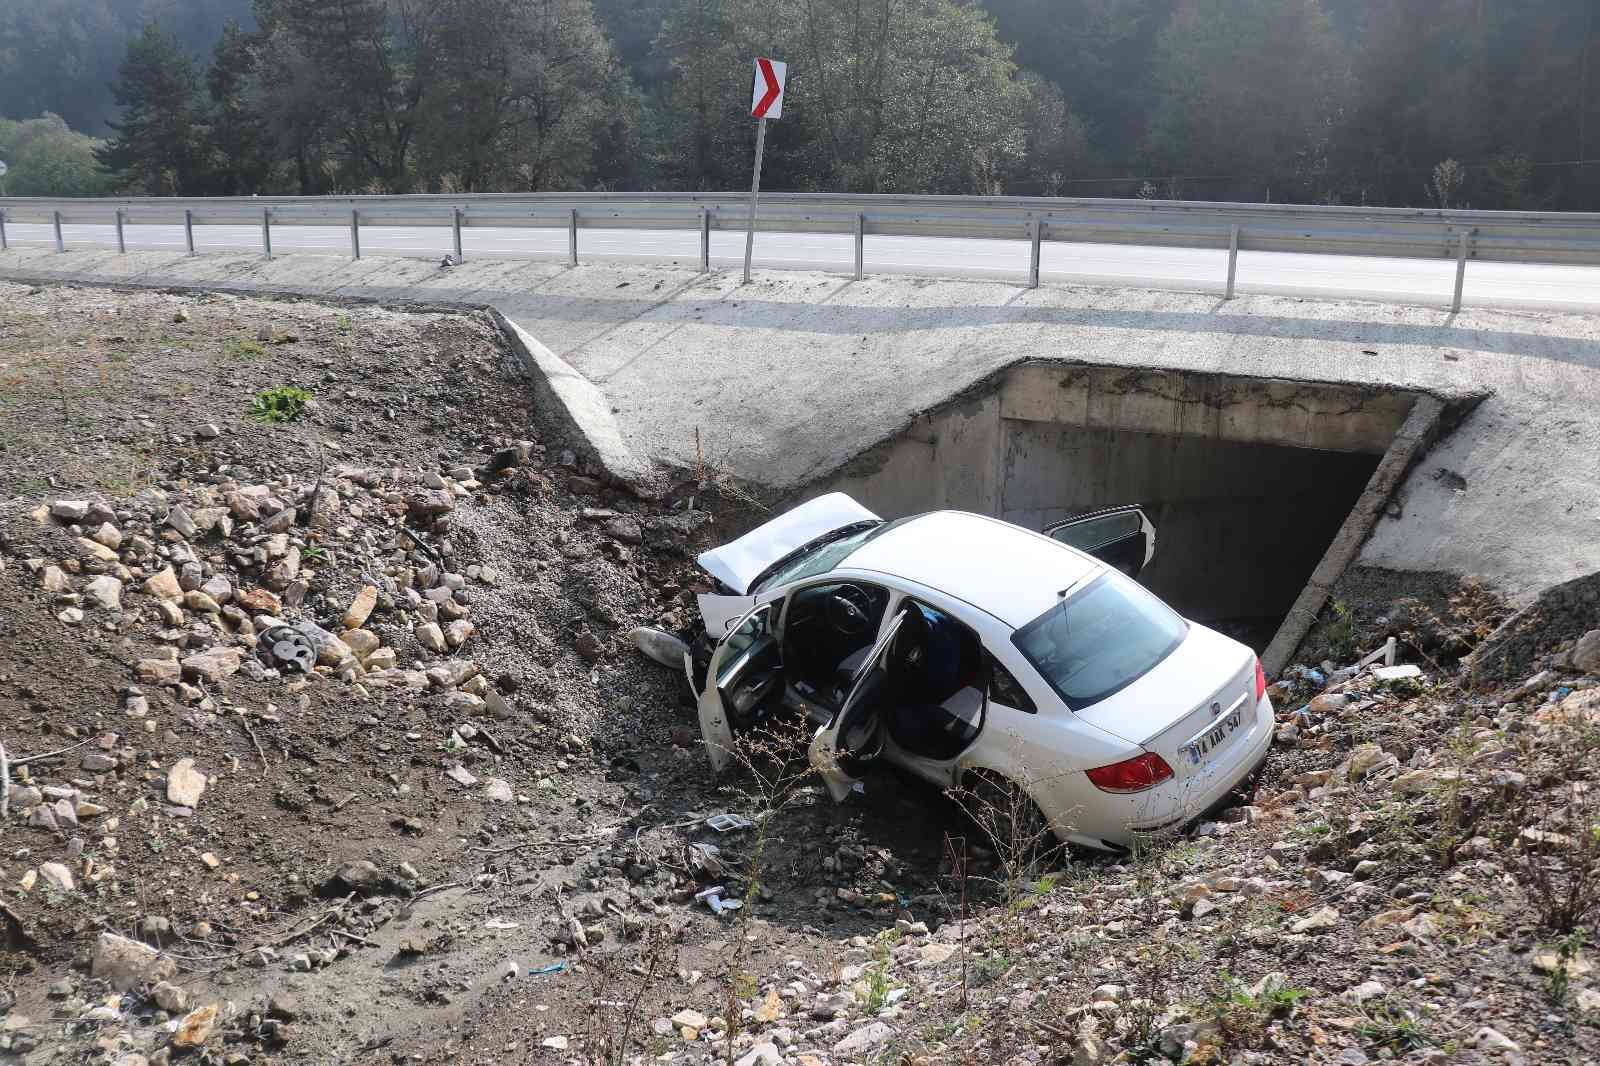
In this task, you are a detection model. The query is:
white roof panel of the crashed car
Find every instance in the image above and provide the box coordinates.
[840,511,1102,627]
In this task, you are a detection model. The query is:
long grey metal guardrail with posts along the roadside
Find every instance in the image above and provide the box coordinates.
[0,192,1600,311]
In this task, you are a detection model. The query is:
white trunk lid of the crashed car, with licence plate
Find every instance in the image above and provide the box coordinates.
[1077,626,1256,779]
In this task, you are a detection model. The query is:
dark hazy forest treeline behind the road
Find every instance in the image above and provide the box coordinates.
[0,0,1600,210]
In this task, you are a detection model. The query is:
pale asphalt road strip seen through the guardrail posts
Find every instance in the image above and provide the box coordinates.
[8,222,1600,311]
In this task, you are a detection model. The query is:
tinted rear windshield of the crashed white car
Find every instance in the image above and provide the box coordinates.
[1011,573,1189,711]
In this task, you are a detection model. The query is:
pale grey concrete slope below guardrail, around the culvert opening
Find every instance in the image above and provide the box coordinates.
[0,248,1600,600]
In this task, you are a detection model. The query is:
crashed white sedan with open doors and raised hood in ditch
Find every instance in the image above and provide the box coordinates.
[668,493,1274,850]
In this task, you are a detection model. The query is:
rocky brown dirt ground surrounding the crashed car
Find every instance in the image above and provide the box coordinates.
[0,285,1600,1066]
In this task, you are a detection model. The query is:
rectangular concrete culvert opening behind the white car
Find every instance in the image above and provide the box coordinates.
[805,362,1483,672]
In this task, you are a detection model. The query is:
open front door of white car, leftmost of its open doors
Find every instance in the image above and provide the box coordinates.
[699,603,784,773]
